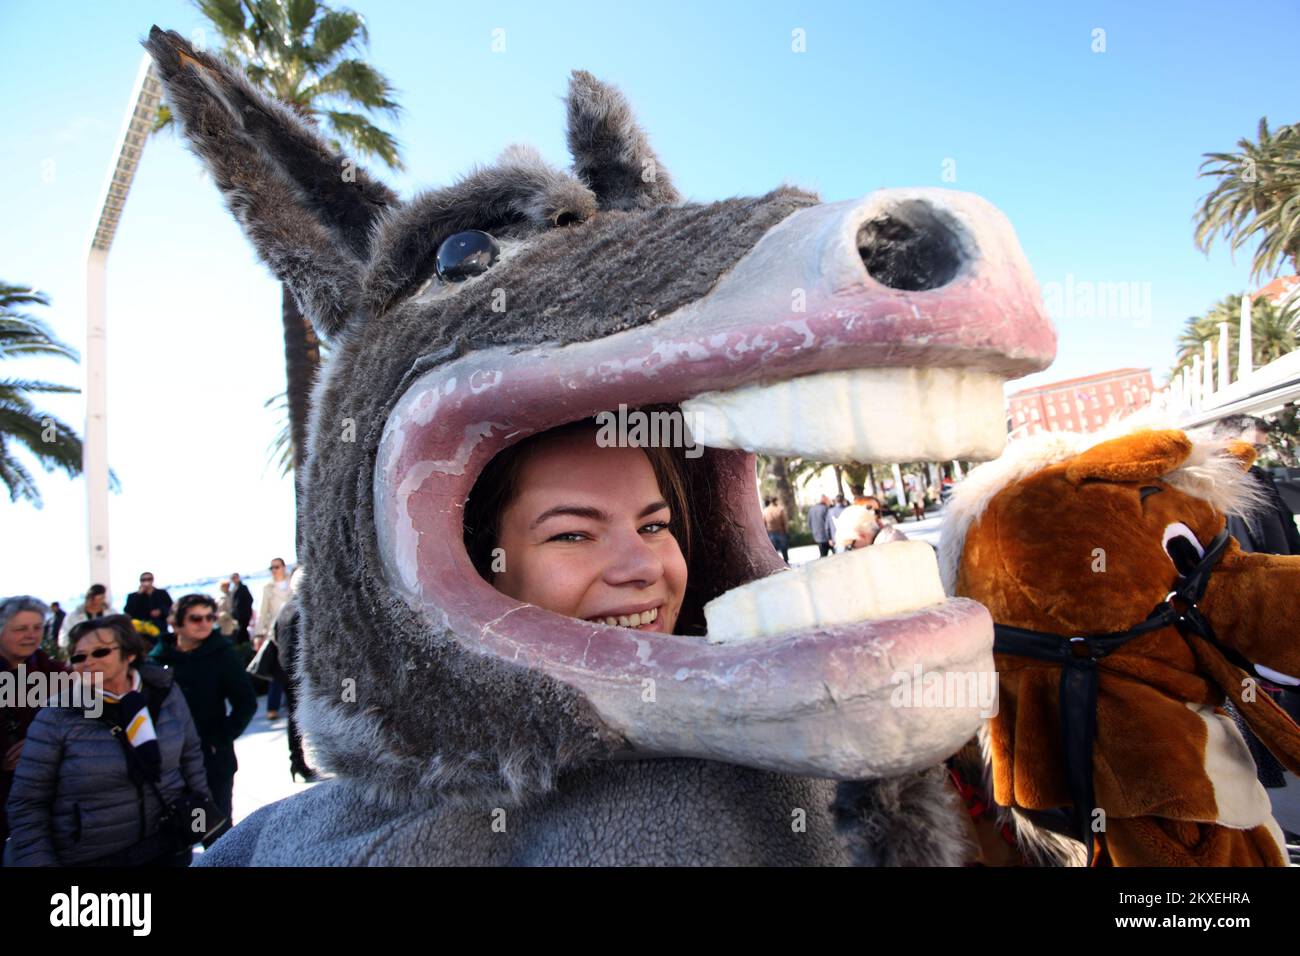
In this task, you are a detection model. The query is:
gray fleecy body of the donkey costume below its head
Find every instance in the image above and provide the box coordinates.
[198,760,974,866]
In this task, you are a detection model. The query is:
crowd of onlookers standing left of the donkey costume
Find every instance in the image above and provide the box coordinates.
[0,558,316,866]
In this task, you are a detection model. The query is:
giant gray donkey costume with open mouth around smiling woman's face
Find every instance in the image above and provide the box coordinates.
[146,29,1056,862]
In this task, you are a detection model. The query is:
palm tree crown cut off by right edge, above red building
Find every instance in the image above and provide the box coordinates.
[1195,117,1300,278]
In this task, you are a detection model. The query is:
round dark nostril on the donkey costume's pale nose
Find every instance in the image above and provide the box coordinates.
[858,199,966,291]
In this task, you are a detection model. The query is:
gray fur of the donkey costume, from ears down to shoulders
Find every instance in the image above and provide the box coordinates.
[144,27,969,865]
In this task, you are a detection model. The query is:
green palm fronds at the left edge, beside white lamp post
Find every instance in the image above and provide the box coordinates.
[0,281,94,507]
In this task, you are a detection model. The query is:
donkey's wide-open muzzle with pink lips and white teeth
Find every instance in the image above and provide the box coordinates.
[374,190,1056,779]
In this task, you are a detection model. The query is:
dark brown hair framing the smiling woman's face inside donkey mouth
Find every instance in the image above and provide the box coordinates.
[462,418,692,584]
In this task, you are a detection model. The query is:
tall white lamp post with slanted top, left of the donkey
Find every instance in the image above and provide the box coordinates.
[82,53,163,587]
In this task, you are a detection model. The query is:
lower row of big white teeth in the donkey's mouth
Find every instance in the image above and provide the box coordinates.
[705,541,945,644]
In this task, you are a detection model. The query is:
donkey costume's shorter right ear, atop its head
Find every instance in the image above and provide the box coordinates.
[568,70,681,209]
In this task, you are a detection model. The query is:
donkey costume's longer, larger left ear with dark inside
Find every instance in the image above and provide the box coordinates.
[144,26,398,336]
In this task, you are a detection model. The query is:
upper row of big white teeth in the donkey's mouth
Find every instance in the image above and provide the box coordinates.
[681,368,1006,462]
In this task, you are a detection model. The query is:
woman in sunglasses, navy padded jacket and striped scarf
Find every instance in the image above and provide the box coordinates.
[5,614,217,866]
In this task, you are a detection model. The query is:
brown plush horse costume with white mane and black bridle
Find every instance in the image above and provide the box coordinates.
[940,431,1300,866]
